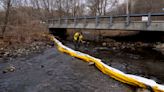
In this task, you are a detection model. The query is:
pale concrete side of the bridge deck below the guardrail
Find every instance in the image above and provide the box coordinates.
[49,21,164,31]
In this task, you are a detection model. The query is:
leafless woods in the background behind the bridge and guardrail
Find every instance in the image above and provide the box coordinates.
[0,0,164,38]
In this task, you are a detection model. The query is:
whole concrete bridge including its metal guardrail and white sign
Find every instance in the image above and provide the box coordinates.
[48,13,164,31]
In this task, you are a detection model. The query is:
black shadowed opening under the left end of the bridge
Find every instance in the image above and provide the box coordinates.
[49,28,67,40]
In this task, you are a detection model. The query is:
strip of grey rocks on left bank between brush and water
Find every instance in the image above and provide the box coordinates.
[0,41,51,58]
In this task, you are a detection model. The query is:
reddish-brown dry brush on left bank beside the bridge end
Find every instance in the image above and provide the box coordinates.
[0,22,48,48]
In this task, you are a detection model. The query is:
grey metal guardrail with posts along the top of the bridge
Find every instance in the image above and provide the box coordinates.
[48,13,164,26]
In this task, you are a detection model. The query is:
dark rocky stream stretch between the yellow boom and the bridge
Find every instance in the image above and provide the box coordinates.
[64,39,164,84]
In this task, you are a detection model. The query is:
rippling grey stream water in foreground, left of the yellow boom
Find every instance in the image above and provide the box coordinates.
[0,48,135,92]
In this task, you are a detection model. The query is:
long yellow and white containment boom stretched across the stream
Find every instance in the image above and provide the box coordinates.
[49,36,164,92]
